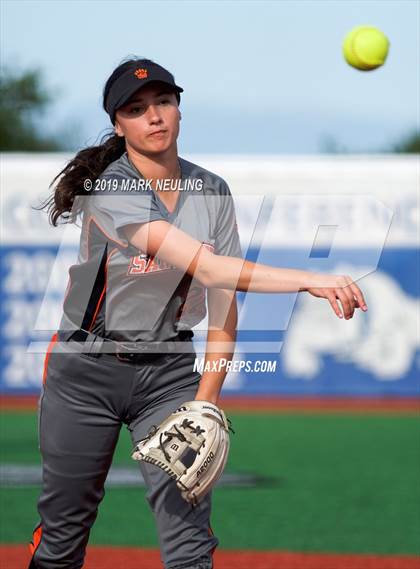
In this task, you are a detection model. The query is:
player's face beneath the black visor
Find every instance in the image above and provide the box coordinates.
[115,83,181,155]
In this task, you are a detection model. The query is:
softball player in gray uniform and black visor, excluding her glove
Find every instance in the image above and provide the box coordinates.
[30,59,366,569]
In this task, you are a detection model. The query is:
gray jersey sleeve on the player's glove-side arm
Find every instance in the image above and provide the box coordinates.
[214,183,243,258]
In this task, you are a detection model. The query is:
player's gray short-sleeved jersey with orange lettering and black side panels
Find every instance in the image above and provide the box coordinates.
[62,153,242,341]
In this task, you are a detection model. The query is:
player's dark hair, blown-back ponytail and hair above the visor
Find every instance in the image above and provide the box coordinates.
[35,56,151,226]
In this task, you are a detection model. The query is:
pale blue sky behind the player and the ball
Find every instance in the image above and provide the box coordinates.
[1,0,420,155]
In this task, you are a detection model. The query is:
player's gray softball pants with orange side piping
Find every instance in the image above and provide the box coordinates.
[30,342,218,569]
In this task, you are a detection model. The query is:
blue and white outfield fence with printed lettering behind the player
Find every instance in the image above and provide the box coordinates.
[0,154,420,397]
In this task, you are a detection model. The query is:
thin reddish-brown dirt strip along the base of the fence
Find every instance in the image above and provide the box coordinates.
[0,395,420,415]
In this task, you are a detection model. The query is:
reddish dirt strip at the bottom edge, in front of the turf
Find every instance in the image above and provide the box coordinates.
[0,545,420,569]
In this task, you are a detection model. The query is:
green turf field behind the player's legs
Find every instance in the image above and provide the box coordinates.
[0,411,420,554]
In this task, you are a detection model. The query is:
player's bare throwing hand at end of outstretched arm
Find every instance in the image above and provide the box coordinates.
[305,273,367,320]
